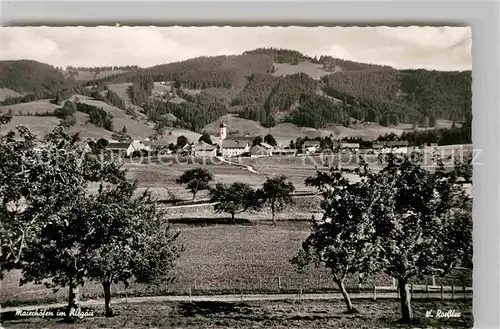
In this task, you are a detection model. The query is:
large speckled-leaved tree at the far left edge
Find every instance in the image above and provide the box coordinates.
[0,127,125,318]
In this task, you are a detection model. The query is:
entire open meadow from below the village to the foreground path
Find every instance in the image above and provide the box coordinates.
[0,150,471,305]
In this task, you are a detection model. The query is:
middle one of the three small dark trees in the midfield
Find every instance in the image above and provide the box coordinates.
[210,182,262,223]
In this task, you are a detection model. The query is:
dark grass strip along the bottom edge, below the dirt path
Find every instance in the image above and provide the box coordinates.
[2,300,473,329]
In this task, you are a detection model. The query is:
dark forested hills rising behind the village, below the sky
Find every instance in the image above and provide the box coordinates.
[0,48,472,132]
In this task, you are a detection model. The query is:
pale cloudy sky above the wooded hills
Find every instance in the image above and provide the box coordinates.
[0,26,472,71]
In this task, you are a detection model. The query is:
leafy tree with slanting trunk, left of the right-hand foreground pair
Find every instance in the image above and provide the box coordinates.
[290,167,377,313]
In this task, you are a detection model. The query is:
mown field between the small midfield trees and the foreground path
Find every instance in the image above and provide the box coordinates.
[0,220,471,305]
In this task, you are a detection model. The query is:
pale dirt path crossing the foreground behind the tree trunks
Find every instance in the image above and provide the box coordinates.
[0,291,472,313]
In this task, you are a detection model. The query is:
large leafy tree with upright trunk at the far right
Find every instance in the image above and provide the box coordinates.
[366,153,472,321]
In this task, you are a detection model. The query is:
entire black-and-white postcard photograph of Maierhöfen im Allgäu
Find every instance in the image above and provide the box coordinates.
[0,24,474,329]
